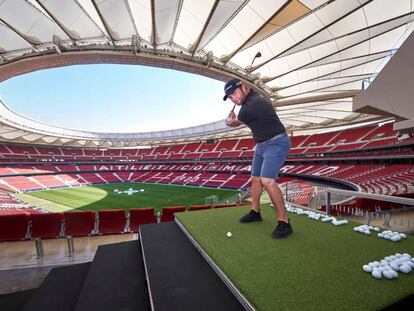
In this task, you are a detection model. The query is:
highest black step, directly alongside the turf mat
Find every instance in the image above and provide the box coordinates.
[140,222,245,311]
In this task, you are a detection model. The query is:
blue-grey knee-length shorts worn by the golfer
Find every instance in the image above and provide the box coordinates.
[252,133,290,179]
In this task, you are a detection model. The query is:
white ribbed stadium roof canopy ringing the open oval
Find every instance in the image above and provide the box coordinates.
[0,0,414,147]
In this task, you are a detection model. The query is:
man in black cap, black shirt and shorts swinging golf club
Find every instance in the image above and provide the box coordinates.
[223,79,293,239]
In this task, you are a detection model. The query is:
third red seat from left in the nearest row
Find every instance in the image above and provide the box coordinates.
[63,211,95,236]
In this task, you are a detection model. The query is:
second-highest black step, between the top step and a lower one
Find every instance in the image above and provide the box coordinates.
[75,240,150,311]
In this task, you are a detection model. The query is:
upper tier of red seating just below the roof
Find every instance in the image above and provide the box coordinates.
[0,123,414,162]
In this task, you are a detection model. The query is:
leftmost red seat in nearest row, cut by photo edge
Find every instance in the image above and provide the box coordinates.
[0,213,29,241]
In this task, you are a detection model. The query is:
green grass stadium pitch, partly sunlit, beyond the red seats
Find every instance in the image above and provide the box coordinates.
[16,183,238,212]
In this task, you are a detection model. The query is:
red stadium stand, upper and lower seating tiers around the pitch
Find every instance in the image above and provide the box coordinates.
[0,123,414,217]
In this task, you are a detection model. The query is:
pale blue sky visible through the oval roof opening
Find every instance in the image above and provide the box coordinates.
[0,64,233,133]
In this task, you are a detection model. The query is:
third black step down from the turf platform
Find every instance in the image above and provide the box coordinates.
[23,263,90,311]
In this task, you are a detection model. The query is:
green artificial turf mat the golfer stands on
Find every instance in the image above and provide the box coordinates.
[175,204,414,311]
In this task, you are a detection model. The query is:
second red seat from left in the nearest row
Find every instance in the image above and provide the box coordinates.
[31,213,63,238]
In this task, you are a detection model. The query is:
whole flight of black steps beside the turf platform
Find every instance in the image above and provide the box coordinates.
[0,222,245,311]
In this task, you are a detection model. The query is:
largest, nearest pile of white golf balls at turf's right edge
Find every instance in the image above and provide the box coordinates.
[362,253,414,280]
